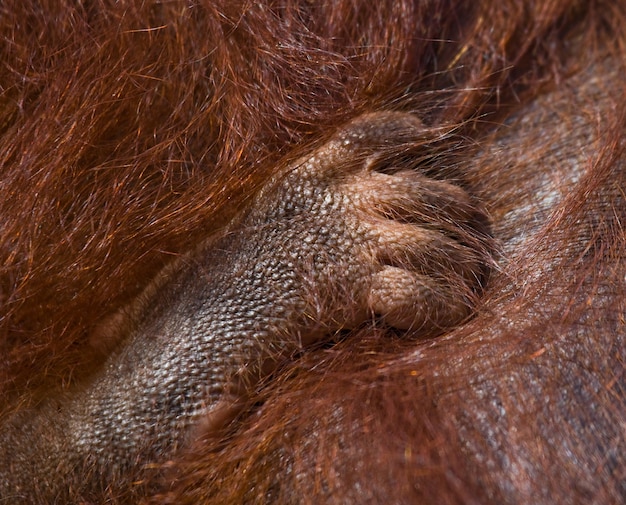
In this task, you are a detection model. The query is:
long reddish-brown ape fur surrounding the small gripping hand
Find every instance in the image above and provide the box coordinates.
[0,0,626,503]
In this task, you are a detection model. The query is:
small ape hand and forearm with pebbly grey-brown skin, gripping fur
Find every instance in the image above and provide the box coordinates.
[0,113,485,503]
